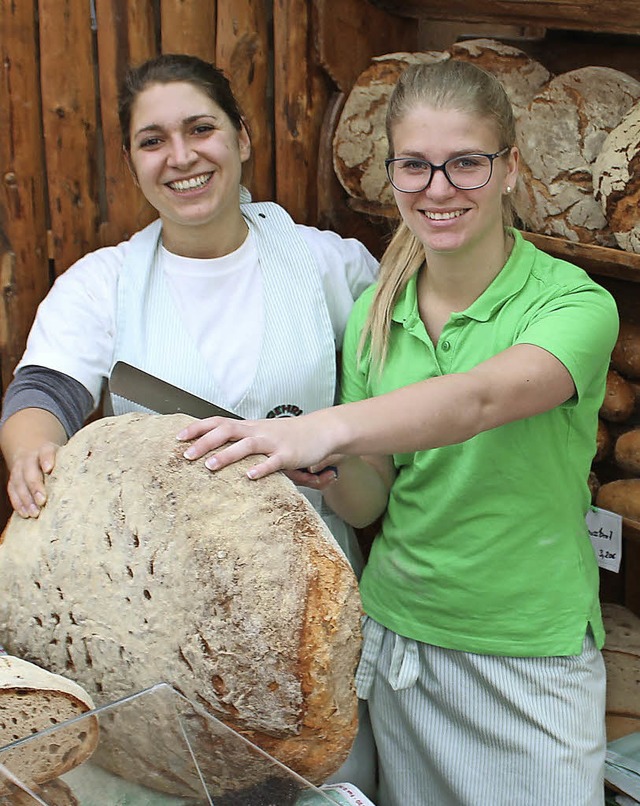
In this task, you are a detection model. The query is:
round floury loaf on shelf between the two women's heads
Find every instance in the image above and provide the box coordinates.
[333,51,449,205]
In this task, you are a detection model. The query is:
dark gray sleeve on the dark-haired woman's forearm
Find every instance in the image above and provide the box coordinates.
[0,365,93,437]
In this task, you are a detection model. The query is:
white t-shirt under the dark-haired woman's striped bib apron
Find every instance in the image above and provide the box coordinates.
[17,225,378,405]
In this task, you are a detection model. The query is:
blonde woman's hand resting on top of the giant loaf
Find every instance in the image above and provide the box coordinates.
[177,409,338,482]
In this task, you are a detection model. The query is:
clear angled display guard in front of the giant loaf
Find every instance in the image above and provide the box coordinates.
[0,684,362,806]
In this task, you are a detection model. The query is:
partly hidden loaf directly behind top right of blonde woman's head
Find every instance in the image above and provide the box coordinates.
[449,39,551,118]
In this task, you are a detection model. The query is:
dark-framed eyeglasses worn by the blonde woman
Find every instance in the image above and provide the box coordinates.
[384,146,510,193]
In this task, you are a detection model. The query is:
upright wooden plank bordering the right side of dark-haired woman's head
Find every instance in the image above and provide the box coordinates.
[216,0,275,201]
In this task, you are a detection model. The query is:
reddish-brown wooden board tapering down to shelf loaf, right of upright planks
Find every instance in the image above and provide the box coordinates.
[315,0,419,93]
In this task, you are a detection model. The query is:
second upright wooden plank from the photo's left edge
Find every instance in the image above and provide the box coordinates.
[39,0,100,274]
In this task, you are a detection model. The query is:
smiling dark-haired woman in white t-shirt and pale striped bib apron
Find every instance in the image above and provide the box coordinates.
[0,54,377,794]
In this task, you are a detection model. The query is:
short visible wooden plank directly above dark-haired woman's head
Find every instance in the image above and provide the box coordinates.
[160,0,216,62]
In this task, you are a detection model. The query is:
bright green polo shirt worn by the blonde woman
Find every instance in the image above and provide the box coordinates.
[342,232,618,656]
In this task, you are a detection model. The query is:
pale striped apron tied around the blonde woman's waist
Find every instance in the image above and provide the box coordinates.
[356,618,606,806]
